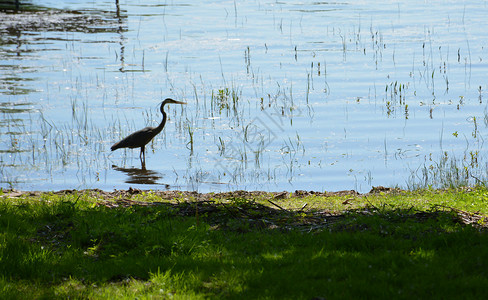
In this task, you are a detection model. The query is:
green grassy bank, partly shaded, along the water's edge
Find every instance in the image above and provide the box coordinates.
[0,187,488,299]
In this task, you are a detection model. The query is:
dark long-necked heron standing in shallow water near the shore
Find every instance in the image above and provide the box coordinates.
[110,98,186,166]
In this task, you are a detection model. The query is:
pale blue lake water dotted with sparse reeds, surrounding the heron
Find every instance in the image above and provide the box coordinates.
[0,0,488,192]
